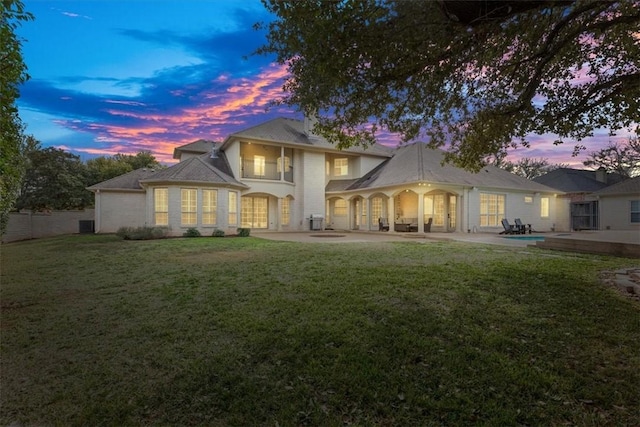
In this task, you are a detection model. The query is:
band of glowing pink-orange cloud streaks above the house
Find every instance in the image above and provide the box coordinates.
[58,64,287,163]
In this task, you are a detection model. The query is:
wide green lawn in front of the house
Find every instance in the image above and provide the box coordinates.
[0,236,640,426]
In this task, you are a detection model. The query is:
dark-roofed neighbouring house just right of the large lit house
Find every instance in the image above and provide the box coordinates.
[534,168,624,230]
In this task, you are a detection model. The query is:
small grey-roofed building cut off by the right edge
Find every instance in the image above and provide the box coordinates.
[594,176,640,232]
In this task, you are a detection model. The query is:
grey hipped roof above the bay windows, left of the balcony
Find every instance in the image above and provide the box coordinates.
[140,153,246,187]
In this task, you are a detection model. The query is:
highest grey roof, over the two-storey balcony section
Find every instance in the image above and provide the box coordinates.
[222,117,392,157]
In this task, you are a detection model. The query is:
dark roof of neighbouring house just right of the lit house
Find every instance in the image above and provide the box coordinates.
[533,168,623,193]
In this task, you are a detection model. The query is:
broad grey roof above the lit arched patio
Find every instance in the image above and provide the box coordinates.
[336,142,556,193]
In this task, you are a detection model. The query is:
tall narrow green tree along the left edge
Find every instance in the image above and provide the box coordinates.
[0,0,33,235]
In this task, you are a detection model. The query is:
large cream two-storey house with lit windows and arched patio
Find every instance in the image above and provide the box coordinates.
[89,118,561,235]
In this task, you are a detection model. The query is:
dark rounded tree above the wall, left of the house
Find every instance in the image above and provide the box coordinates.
[16,143,93,211]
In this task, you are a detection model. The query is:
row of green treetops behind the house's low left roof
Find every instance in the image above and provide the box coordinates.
[87,150,162,185]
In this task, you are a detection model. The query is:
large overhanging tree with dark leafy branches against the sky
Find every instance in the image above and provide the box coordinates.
[257,0,640,170]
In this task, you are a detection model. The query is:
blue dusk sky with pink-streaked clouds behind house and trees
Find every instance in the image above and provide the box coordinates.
[18,0,627,167]
